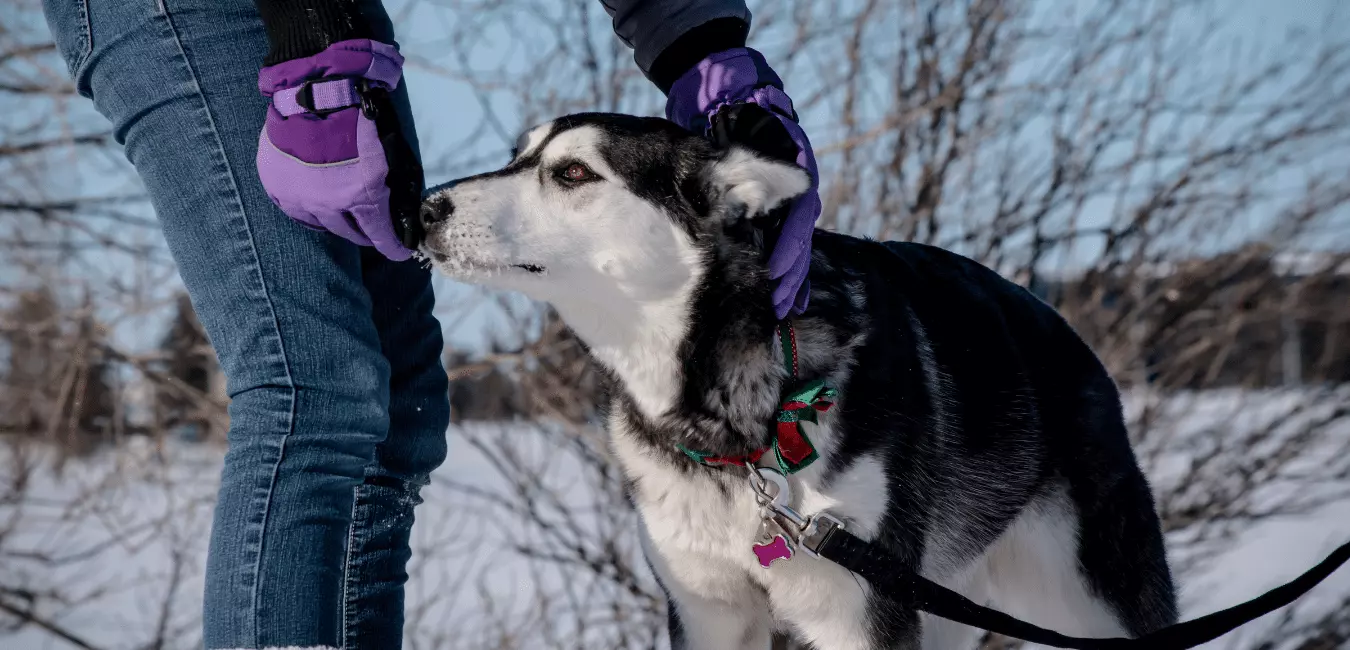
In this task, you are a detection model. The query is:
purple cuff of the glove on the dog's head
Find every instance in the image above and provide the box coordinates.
[666,47,797,135]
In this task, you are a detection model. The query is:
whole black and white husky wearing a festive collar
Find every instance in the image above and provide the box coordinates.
[421,114,1177,650]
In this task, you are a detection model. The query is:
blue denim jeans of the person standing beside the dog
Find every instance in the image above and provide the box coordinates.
[45,0,450,649]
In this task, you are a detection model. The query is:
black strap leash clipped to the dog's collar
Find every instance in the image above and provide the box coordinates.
[802,518,1350,650]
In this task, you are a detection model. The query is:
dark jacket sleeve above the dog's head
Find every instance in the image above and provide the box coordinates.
[601,0,751,92]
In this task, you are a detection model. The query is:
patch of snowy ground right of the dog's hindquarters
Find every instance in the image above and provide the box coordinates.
[1127,386,1350,650]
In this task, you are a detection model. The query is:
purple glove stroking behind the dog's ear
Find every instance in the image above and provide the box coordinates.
[666,47,821,319]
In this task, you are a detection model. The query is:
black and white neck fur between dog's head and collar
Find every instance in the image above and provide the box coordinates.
[555,221,804,455]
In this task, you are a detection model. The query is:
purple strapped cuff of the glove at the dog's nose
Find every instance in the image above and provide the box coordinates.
[258,38,404,97]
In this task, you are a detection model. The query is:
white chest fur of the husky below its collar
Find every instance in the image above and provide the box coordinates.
[610,418,887,649]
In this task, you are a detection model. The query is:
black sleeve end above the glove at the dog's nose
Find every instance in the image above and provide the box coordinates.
[254,0,378,66]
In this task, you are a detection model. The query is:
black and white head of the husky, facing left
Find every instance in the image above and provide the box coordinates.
[421,114,810,316]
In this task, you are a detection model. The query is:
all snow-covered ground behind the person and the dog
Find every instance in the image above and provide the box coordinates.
[0,391,1350,650]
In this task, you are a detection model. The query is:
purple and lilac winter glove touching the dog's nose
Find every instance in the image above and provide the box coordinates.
[258,39,423,261]
